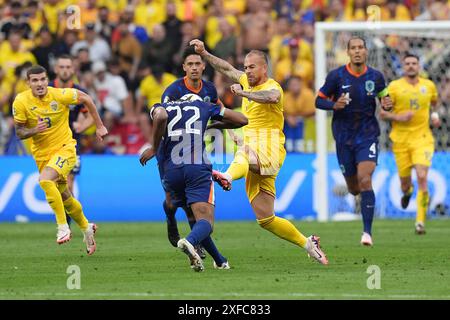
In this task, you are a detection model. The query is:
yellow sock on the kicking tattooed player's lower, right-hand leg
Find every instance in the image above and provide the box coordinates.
[256,215,307,248]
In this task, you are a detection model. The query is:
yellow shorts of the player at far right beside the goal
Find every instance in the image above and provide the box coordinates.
[392,139,434,178]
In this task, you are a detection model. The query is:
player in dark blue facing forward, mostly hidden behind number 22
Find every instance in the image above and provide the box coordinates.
[156,46,219,252]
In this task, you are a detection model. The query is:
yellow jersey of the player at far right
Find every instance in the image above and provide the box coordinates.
[388,77,437,142]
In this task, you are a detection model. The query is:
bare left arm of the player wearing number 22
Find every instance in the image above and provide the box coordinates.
[139,106,169,166]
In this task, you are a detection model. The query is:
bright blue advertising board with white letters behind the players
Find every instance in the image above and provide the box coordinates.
[0,153,450,222]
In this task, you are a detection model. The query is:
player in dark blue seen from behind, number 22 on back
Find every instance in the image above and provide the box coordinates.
[139,94,248,272]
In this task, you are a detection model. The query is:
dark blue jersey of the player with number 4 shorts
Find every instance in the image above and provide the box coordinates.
[319,65,386,145]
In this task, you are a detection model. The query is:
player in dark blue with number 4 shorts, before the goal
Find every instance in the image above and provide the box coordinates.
[316,37,392,246]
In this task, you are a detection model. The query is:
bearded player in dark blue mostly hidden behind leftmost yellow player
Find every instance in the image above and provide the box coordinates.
[48,54,94,194]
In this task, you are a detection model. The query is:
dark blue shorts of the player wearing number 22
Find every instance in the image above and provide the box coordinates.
[162,165,214,207]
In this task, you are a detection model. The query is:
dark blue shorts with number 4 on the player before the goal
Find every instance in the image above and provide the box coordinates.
[336,140,378,177]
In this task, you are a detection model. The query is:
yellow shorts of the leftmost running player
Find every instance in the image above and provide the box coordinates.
[36,145,77,181]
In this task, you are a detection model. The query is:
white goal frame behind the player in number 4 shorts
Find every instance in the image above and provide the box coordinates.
[313,21,450,221]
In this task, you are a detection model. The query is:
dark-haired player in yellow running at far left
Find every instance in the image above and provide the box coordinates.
[13,66,108,255]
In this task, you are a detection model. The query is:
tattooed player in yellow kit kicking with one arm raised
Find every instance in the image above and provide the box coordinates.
[189,39,328,264]
